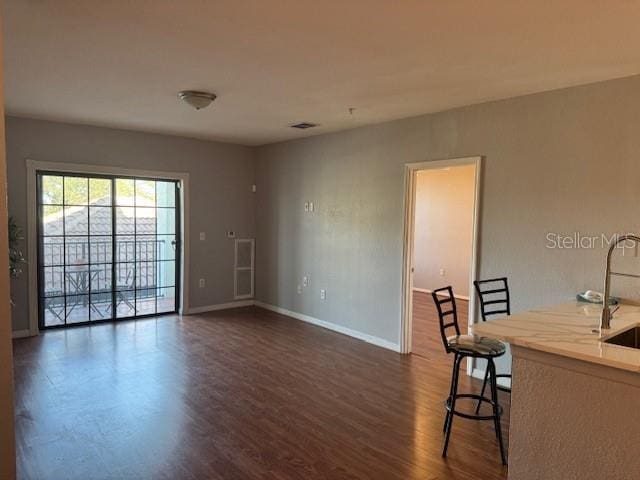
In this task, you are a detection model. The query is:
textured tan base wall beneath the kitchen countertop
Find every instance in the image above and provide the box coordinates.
[509,353,640,480]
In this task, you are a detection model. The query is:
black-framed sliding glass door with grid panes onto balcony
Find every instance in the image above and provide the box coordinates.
[38,172,180,328]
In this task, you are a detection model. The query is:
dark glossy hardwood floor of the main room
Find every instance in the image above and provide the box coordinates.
[14,308,508,480]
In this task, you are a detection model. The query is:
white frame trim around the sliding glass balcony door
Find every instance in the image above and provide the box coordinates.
[26,159,189,336]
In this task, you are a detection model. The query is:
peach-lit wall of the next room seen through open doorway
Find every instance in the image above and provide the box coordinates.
[413,165,476,297]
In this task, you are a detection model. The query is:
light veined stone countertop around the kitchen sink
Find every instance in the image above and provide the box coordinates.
[473,302,640,373]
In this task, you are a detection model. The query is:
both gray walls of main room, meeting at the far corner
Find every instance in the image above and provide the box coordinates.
[7,77,640,356]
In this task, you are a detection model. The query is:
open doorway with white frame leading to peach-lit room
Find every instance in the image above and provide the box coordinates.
[401,157,481,368]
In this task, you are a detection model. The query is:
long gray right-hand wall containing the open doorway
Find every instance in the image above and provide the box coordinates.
[256,76,640,352]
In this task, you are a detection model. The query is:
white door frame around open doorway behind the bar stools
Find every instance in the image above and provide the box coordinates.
[400,156,482,375]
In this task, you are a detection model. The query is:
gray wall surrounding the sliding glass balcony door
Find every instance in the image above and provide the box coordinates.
[6,117,255,330]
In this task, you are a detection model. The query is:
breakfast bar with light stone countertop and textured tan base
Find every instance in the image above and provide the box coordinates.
[473,302,640,480]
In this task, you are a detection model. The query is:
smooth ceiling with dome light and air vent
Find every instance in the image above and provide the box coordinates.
[4,0,640,145]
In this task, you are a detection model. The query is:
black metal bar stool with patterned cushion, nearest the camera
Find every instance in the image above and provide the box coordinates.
[431,286,507,465]
